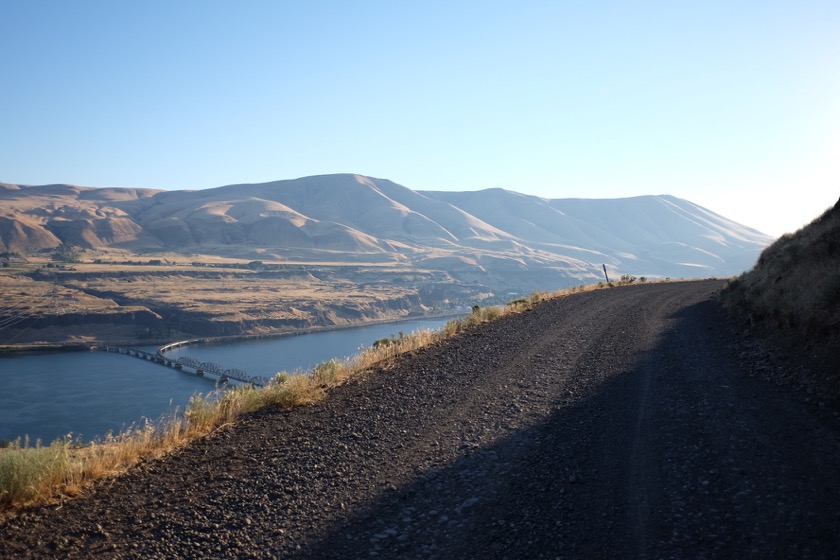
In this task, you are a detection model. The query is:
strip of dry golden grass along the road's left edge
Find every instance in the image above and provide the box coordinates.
[0,277,648,513]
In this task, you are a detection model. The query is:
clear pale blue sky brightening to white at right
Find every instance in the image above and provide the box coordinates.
[0,0,840,235]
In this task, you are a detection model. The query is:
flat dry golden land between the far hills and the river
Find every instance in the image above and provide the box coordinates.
[0,263,430,343]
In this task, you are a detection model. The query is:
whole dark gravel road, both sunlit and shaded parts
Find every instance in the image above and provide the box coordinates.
[0,281,840,560]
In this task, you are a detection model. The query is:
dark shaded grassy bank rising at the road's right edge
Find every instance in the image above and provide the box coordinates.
[722,197,840,398]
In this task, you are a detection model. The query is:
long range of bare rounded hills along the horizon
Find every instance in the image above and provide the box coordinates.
[0,174,772,289]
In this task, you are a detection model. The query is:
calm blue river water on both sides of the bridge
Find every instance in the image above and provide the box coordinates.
[0,319,446,443]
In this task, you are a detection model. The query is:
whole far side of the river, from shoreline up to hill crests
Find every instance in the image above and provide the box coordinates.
[0,174,771,346]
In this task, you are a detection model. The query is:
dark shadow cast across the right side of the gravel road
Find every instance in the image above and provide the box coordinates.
[300,300,840,559]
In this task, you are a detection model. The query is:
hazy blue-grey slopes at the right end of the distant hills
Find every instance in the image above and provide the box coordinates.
[427,189,769,277]
